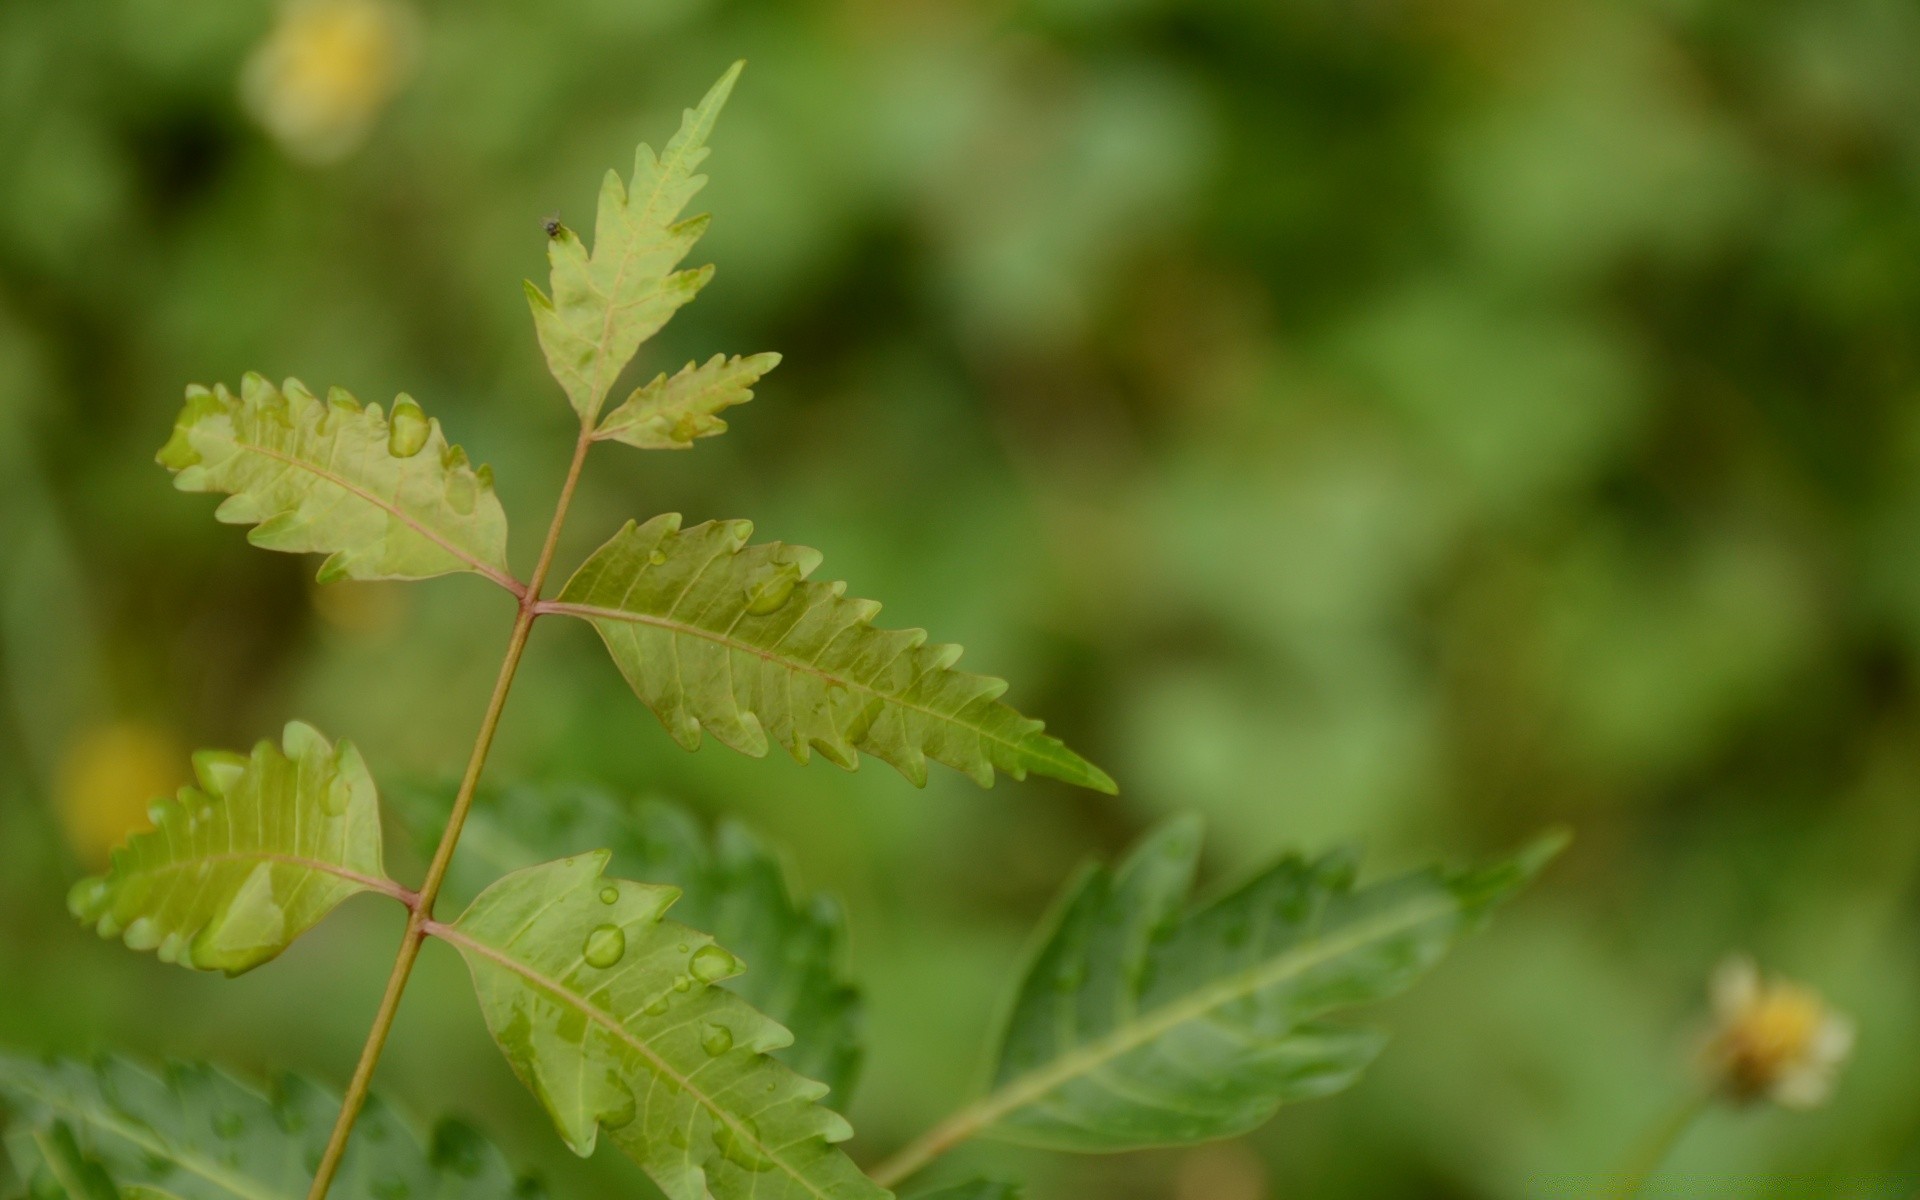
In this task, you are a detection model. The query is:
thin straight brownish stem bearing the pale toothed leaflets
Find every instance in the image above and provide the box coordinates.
[307,424,593,1200]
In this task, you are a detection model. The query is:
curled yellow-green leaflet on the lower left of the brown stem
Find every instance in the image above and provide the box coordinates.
[67,722,403,975]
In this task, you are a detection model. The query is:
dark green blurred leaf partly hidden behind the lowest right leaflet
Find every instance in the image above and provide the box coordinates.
[388,787,860,1108]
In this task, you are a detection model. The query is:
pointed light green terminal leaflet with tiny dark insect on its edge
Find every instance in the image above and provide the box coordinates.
[526,63,745,424]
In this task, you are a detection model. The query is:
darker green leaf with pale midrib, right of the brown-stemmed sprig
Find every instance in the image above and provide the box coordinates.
[975,820,1563,1152]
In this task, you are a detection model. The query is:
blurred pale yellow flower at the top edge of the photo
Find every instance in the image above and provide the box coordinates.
[240,0,417,163]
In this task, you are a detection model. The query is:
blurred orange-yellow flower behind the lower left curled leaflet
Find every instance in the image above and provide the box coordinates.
[54,722,188,868]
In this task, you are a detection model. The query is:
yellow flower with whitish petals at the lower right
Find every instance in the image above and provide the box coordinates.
[1707,956,1853,1108]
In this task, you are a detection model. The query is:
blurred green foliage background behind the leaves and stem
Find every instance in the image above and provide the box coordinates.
[0,0,1920,1200]
